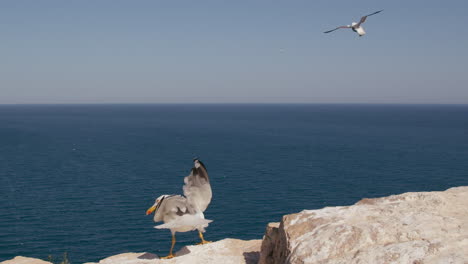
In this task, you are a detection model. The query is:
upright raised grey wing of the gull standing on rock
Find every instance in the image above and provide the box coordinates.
[183,160,212,212]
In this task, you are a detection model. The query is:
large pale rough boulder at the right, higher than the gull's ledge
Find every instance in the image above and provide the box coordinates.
[259,187,468,264]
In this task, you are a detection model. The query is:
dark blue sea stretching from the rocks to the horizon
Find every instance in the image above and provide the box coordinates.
[0,105,468,263]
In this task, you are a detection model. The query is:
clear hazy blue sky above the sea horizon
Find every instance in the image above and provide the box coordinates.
[0,0,468,103]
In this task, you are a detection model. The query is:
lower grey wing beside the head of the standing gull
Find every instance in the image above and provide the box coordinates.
[154,195,195,222]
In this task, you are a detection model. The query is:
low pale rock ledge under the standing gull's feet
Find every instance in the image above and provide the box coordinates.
[85,238,262,264]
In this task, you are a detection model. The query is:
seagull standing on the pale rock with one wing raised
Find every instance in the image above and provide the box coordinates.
[146,158,212,259]
